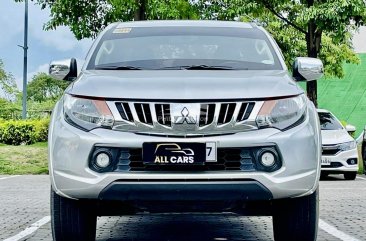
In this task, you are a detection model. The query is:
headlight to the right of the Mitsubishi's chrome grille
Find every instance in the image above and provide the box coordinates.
[256,95,306,130]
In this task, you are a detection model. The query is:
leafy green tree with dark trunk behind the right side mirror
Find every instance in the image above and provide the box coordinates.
[239,0,366,106]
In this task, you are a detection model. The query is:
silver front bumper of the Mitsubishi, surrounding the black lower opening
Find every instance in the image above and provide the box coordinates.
[49,101,320,200]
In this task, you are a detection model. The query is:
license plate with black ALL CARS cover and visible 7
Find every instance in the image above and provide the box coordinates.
[142,142,217,165]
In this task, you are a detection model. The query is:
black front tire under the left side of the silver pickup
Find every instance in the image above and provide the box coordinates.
[51,188,97,241]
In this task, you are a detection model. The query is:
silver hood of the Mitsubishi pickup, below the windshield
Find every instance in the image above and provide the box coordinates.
[67,70,303,100]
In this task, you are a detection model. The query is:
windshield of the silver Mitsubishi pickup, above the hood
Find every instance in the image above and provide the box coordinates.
[88,27,281,70]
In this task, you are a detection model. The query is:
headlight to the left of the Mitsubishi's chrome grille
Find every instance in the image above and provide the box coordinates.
[64,94,114,131]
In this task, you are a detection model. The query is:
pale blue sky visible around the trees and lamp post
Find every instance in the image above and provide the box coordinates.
[0,0,366,89]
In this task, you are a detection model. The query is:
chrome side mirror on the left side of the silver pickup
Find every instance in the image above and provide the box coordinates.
[49,58,78,81]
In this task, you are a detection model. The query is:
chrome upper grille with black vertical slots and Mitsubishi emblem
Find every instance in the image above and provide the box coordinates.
[107,101,263,136]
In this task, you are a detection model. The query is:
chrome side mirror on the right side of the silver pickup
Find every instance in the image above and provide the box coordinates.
[292,57,323,81]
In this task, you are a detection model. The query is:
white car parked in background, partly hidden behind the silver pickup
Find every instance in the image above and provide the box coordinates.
[318,109,358,180]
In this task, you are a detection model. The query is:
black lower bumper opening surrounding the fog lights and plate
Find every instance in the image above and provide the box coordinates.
[89,146,282,173]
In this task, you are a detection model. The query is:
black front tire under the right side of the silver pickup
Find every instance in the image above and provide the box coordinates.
[273,189,319,241]
